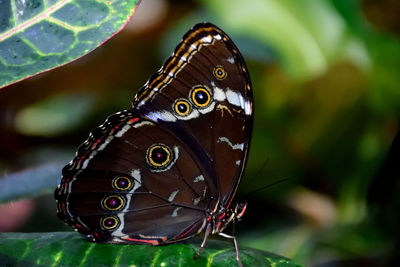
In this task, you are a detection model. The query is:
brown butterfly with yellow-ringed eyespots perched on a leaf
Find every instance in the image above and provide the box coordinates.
[55,23,254,265]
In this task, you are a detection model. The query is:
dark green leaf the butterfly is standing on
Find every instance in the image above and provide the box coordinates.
[0,232,300,267]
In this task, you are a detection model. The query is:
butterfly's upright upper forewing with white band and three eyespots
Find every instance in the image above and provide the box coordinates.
[133,24,253,205]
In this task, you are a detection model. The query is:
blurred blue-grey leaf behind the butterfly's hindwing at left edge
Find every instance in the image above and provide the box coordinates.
[0,163,65,204]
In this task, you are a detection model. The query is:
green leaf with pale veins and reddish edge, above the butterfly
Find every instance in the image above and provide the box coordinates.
[0,0,140,88]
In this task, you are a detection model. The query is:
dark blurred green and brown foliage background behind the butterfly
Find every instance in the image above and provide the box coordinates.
[0,0,400,266]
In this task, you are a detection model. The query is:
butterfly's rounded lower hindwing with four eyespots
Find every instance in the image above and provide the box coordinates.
[56,111,216,244]
